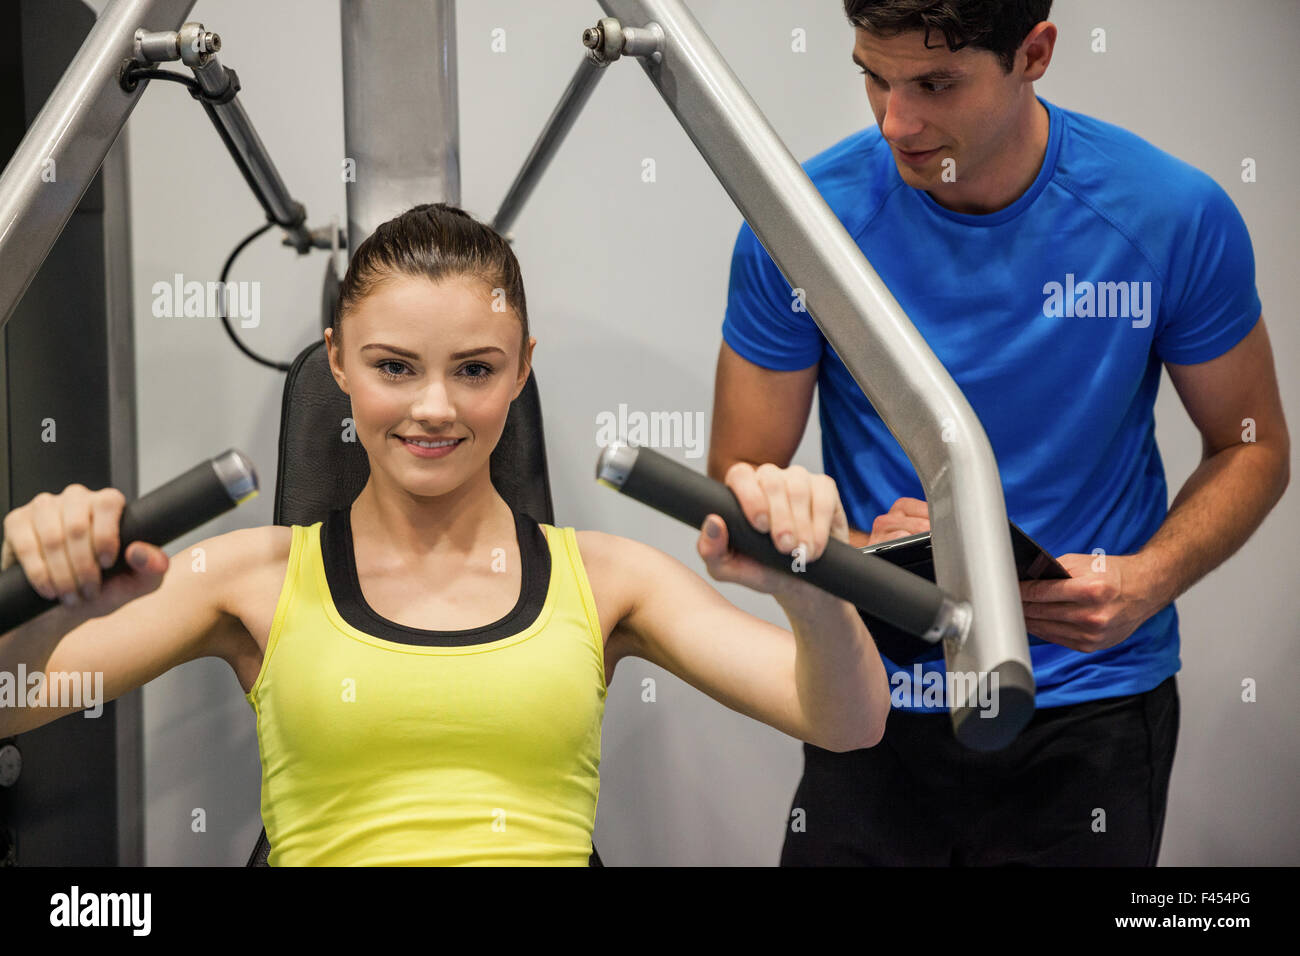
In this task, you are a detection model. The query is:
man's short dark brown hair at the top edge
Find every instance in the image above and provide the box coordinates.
[844,0,1052,73]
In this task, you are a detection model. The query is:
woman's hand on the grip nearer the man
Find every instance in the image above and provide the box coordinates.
[697,462,849,597]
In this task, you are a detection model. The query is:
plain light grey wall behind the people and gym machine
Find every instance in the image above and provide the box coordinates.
[101,0,1300,865]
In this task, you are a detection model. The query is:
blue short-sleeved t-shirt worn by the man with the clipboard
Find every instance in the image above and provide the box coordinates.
[723,98,1261,710]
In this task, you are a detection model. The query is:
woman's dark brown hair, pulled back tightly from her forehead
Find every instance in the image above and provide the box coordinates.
[330,203,528,368]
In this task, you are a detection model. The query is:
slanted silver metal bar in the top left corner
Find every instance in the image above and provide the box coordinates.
[0,0,194,326]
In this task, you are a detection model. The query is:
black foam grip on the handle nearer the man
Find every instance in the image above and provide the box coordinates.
[608,447,944,636]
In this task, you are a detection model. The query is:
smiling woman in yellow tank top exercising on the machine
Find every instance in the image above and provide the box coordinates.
[0,204,889,865]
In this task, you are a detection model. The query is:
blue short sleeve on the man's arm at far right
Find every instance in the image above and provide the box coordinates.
[1156,170,1262,365]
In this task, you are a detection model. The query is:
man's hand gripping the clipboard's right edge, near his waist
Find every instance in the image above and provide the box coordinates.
[1021,554,1169,654]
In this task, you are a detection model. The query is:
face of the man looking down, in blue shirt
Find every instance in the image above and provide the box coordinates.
[853,27,1024,196]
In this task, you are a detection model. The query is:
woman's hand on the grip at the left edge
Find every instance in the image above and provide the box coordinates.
[0,484,170,618]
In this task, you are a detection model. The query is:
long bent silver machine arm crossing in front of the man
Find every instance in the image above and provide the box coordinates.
[601,0,1035,749]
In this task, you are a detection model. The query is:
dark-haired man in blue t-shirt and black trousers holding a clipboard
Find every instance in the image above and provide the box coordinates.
[709,0,1290,865]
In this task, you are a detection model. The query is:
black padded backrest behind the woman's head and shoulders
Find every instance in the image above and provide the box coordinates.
[248,339,579,866]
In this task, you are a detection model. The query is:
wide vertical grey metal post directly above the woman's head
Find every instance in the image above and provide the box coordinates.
[339,0,460,254]
